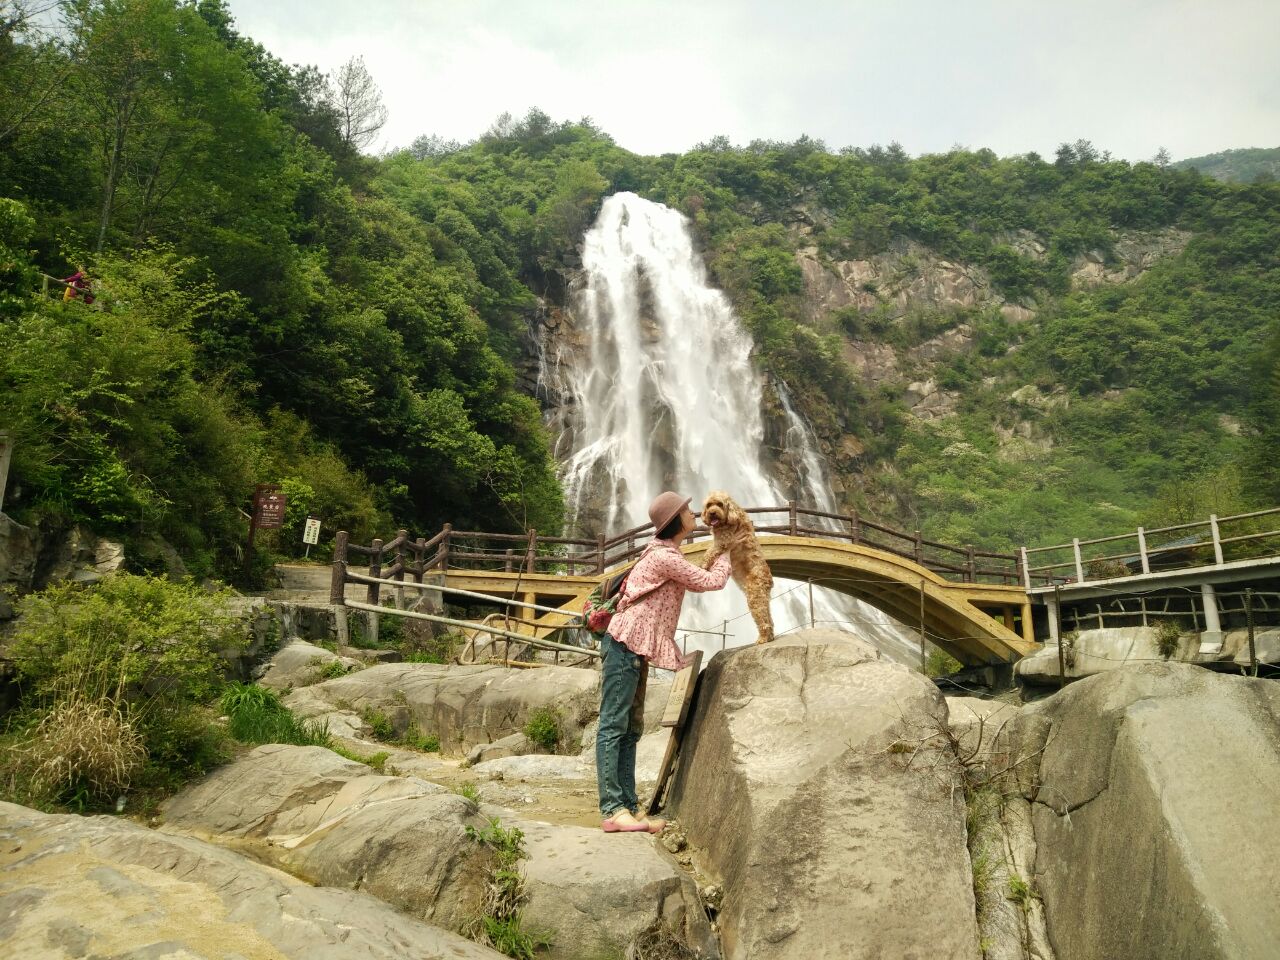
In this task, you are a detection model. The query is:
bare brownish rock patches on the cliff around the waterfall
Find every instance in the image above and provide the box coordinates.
[517,228,1190,527]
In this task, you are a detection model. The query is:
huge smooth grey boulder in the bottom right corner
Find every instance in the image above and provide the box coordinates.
[997,663,1280,960]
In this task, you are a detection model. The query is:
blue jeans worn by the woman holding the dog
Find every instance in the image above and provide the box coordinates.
[595,634,649,817]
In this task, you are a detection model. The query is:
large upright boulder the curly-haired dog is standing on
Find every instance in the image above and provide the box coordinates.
[668,630,979,960]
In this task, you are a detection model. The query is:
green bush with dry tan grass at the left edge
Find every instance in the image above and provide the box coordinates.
[4,573,238,809]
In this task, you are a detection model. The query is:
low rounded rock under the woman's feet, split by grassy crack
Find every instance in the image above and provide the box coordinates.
[164,745,713,960]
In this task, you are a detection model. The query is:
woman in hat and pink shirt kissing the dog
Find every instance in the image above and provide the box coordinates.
[595,490,731,833]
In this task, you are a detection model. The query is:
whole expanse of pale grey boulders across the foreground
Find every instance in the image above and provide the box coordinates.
[0,631,1280,960]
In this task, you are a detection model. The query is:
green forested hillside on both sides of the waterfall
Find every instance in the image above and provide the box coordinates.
[0,0,1280,572]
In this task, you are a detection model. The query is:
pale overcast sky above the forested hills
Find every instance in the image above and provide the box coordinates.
[230,0,1280,160]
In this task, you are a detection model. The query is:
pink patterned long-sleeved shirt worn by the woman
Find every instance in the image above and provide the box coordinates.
[609,540,732,669]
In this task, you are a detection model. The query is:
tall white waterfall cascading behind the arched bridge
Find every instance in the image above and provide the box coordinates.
[541,193,909,657]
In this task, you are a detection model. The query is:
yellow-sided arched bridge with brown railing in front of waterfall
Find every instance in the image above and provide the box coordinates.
[333,503,1039,664]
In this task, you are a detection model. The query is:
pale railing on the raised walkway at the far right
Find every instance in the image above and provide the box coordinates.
[1020,507,1280,590]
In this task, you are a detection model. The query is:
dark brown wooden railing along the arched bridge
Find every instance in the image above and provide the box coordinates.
[332,500,1024,604]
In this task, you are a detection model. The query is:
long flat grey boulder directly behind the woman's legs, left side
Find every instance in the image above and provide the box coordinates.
[285,663,600,756]
